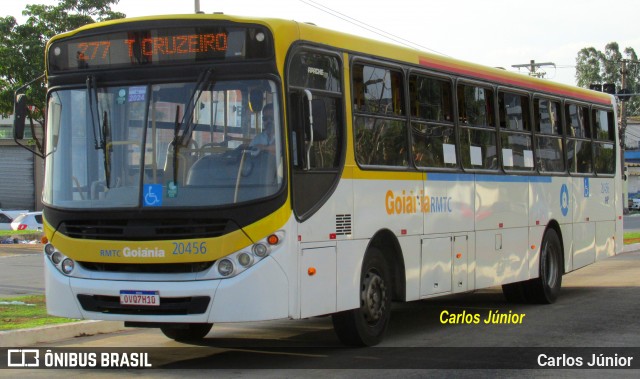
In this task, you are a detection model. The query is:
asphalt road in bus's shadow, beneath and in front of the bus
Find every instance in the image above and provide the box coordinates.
[0,251,640,379]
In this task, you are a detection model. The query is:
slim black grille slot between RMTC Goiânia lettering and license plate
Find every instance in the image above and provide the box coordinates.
[78,261,215,274]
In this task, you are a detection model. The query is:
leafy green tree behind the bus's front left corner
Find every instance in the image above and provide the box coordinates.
[0,0,126,127]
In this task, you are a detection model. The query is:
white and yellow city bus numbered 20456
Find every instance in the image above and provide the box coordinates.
[14,14,623,346]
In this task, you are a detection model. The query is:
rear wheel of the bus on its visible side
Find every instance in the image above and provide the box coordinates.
[525,229,564,304]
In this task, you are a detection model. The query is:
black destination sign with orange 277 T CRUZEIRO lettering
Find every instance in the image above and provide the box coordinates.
[48,26,273,73]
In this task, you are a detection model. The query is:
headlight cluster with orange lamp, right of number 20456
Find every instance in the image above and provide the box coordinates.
[205,230,284,280]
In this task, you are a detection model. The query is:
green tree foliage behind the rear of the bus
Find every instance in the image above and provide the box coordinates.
[576,42,640,116]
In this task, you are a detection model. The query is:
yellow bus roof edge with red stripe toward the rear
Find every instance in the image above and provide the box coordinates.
[47,14,613,105]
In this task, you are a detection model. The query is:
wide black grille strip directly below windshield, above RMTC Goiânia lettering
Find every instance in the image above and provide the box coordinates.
[59,218,237,241]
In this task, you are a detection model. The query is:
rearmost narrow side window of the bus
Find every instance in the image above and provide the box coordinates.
[591,109,618,174]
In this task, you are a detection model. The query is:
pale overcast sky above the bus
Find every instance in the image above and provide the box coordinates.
[5,0,640,85]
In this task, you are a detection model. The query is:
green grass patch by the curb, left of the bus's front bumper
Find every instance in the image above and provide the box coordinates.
[0,295,77,331]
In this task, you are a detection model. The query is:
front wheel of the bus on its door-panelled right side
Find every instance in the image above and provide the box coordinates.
[332,249,392,346]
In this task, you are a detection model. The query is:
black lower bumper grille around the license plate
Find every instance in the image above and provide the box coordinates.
[78,295,211,315]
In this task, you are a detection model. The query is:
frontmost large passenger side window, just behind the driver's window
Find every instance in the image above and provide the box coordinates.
[352,63,409,167]
